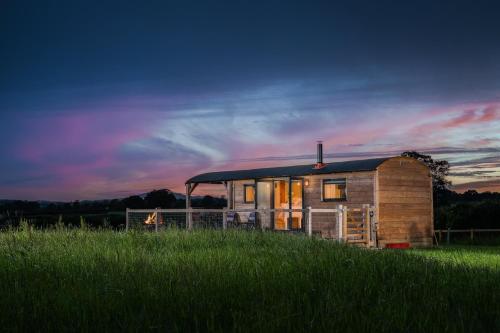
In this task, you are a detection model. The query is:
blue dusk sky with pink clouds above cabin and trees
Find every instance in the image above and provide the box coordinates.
[0,0,500,200]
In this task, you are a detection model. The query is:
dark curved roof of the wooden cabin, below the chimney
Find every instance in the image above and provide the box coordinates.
[186,157,390,184]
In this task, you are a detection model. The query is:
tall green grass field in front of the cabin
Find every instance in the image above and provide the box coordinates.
[0,229,500,332]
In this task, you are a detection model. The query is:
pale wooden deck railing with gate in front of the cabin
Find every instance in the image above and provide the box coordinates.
[126,205,376,245]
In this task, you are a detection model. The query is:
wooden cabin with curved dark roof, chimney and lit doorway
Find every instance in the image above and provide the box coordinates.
[186,146,434,247]
